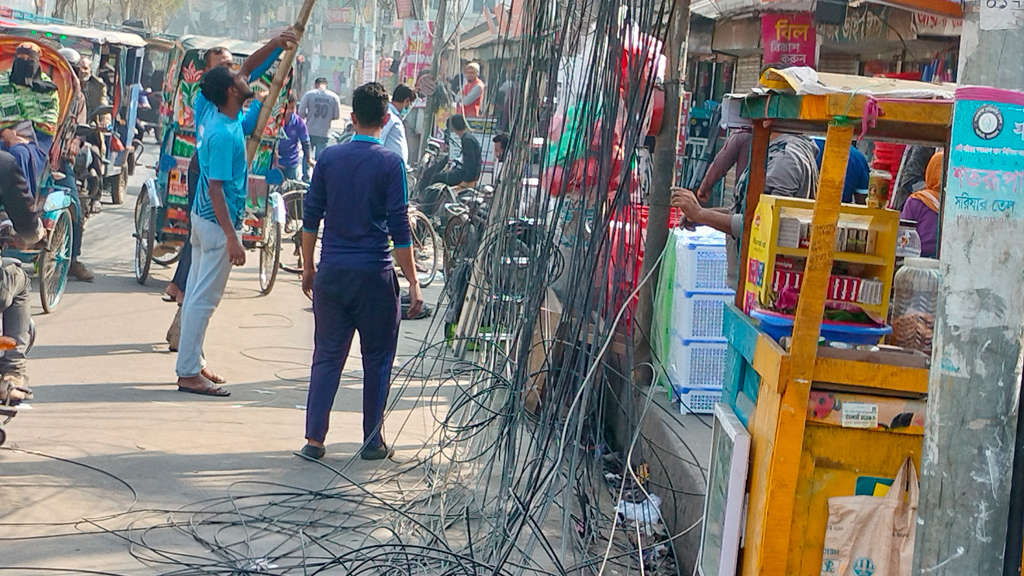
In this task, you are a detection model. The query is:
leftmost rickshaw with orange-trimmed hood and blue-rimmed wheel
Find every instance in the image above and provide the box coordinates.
[0,35,82,314]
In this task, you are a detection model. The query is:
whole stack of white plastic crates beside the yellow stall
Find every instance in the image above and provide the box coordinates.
[665,227,735,414]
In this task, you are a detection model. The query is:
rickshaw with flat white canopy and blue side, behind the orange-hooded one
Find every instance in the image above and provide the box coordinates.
[0,24,145,204]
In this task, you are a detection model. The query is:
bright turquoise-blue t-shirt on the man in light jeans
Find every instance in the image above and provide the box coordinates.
[193,112,249,230]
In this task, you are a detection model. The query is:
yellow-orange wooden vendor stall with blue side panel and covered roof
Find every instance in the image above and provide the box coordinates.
[700,71,952,576]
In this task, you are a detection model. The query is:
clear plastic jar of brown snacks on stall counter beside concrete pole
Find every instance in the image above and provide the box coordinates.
[892,258,939,358]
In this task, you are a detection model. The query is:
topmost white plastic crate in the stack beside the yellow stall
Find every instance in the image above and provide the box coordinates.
[676,227,731,292]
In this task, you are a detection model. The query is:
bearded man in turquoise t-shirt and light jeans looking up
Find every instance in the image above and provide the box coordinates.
[175,67,255,396]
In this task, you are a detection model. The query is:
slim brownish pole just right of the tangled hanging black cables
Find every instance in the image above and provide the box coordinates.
[633,0,690,386]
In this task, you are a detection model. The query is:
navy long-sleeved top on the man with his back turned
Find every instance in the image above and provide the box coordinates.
[302,135,413,270]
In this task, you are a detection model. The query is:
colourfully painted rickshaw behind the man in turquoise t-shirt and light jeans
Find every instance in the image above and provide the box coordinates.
[135,36,284,294]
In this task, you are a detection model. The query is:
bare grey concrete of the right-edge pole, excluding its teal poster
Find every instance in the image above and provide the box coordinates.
[917,0,1024,576]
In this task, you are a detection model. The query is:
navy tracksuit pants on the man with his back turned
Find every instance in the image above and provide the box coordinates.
[306,266,401,448]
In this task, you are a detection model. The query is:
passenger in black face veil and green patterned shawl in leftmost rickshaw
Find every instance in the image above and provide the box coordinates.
[0,42,60,142]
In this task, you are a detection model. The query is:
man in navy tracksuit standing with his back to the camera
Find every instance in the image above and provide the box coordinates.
[302,82,423,460]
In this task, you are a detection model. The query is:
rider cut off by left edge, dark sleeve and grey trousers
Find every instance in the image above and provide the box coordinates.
[0,152,45,404]
